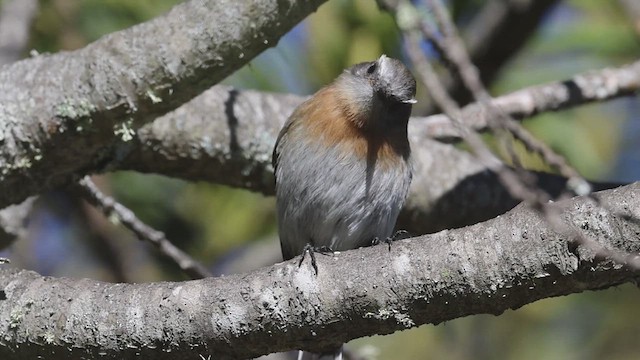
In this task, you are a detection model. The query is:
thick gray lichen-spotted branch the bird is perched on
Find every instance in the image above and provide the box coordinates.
[0,184,640,359]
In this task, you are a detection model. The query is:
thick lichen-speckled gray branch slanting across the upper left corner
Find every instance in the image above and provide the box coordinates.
[0,0,324,207]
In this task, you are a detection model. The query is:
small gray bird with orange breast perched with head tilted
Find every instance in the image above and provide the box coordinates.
[272,55,416,360]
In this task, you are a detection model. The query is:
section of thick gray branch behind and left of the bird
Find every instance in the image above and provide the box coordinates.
[115,86,304,194]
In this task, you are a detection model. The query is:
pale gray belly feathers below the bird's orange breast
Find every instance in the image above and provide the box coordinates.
[276,135,411,259]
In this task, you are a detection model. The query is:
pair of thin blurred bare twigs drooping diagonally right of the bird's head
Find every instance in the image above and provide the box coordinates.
[380,0,640,269]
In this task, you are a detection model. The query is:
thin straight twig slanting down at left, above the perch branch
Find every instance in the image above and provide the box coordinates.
[75,176,212,279]
